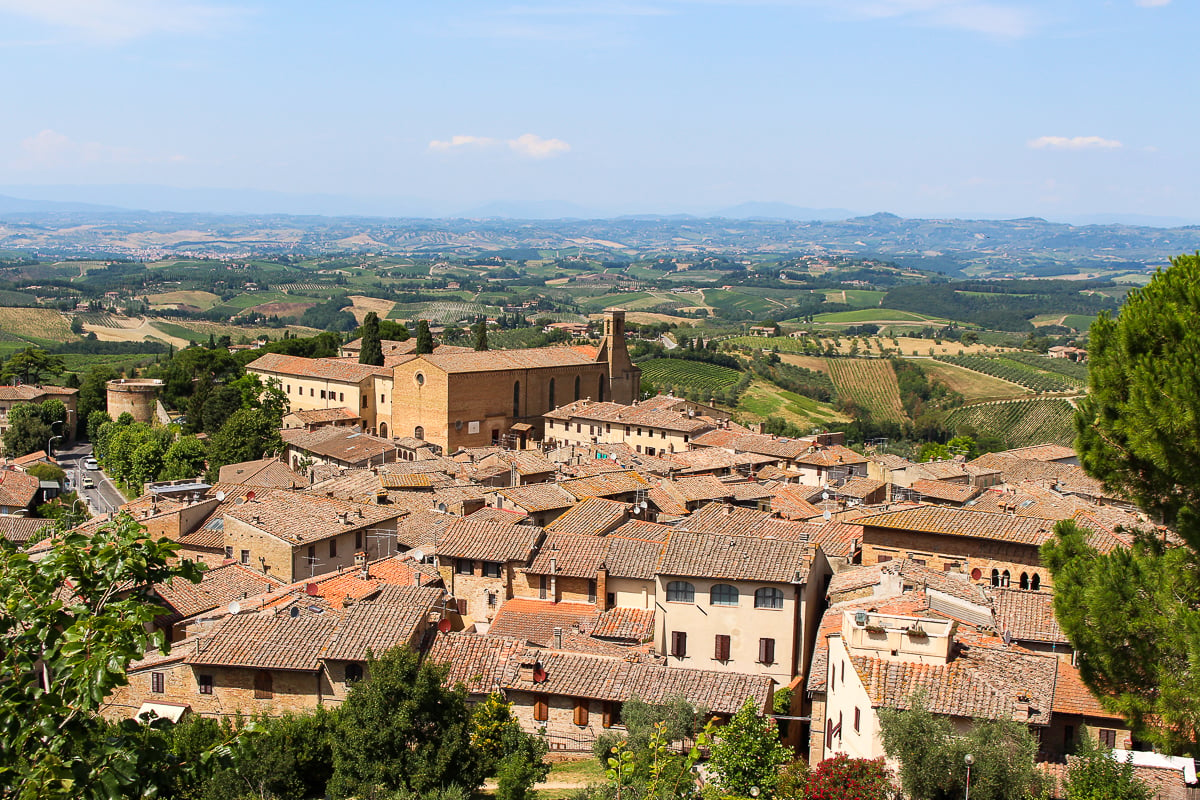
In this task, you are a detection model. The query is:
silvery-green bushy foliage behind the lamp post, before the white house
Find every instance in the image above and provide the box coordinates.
[880,696,1046,800]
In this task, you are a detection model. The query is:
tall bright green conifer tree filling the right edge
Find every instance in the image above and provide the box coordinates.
[1042,254,1200,757]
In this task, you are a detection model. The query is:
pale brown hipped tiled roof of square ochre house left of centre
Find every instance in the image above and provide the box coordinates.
[224,489,402,545]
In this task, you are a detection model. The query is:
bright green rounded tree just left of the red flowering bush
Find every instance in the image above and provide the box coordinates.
[709,697,792,798]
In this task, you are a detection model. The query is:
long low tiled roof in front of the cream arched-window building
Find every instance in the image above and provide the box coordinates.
[428,633,774,714]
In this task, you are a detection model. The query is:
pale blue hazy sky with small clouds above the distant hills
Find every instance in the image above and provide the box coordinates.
[0,0,1200,222]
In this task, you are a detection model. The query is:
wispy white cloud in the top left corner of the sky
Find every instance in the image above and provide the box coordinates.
[0,0,236,43]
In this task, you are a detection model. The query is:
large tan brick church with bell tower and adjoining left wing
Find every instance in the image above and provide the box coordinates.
[246,311,642,452]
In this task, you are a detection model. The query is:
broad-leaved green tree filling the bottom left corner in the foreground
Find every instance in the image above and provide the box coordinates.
[0,515,200,800]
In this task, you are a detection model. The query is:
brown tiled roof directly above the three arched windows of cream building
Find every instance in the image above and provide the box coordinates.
[659,530,811,583]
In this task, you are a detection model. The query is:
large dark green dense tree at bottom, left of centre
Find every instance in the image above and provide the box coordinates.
[329,646,484,798]
